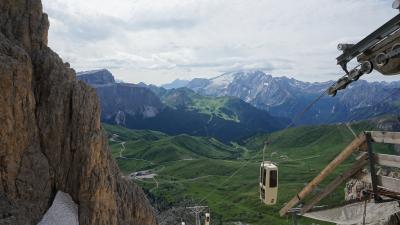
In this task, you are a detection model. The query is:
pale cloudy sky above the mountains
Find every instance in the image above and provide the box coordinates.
[43,0,399,85]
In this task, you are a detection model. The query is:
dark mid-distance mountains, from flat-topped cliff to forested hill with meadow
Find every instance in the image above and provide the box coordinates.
[77,70,290,142]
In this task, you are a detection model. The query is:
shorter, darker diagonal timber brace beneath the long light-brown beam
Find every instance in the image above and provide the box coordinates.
[300,153,368,215]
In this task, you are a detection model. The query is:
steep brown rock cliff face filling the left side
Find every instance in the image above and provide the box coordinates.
[0,0,156,225]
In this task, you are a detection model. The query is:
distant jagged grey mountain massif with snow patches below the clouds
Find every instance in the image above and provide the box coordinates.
[187,70,400,124]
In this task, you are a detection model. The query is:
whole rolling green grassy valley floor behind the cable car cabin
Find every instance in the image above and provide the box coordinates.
[104,122,393,225]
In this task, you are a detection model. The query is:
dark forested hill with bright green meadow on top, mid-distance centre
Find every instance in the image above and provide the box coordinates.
[125,88,289,143]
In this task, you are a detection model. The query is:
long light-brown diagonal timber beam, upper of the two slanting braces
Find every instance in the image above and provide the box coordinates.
[279,134,366,216]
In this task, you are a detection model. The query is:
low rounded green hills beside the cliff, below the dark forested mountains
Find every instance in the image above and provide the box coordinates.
[103,124,238,172]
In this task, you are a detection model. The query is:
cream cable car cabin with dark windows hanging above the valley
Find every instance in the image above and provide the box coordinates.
[260,161,278,205]
